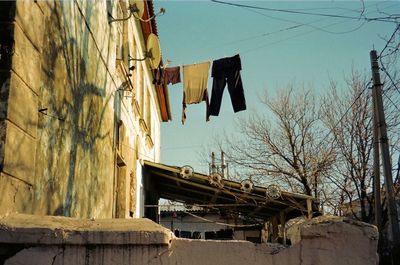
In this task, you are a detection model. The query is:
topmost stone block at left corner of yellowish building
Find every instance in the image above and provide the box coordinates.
[15,1,44,52]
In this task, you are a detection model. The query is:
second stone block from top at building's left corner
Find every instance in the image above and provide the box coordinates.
[11,23,41,94]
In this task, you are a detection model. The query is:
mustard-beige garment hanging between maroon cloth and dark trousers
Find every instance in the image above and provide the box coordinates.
[182,62,211,124]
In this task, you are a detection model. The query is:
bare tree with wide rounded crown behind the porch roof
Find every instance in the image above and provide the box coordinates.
[222,85,335,198]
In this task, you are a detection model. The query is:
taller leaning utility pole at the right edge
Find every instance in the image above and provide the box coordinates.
[370,50,400,245]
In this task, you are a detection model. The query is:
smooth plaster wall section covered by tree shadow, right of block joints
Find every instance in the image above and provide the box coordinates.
[33,1,115,218]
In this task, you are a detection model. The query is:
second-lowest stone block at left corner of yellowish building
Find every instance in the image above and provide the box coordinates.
[3,121,36,184]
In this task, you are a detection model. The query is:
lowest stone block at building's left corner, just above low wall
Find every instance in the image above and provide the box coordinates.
[0,173,33,215]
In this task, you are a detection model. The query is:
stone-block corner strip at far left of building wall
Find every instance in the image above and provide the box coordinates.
[0,1,36,216]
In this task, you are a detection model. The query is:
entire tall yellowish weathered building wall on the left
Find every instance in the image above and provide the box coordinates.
[0,0,161,218]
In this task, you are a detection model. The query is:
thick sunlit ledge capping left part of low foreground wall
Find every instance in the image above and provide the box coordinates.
[0,213,174,245]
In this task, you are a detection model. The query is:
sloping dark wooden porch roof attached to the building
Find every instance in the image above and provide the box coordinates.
[144,161,319,220]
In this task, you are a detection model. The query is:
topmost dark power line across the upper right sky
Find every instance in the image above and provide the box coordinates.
[211,0,398,23]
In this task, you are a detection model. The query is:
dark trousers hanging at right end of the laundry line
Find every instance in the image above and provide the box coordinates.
[208,54,246,119]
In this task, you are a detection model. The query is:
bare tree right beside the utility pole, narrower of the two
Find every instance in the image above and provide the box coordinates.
[322,72,373,222]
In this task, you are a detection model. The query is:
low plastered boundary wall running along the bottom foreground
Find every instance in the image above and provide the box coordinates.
[0,215,377,265]
